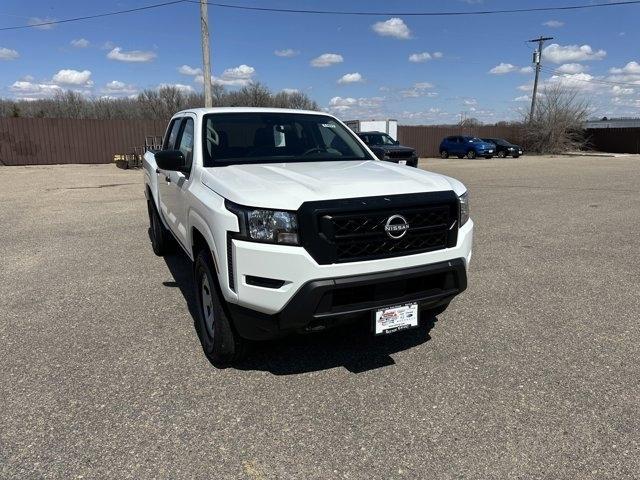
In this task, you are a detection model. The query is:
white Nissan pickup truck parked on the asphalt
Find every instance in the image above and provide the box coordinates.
[144,108,473,365]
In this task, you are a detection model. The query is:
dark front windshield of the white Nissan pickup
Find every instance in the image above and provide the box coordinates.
[202,112,372,167]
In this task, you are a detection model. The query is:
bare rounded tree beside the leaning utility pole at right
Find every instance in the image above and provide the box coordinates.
[524,84,590,153]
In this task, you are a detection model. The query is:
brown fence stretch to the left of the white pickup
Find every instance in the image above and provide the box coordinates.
[0,118,166,165]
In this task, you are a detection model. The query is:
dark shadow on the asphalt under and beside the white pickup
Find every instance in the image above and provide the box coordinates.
[163,252,437,375]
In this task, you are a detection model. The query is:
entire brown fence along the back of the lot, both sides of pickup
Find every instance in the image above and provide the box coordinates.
[0,118,640,165]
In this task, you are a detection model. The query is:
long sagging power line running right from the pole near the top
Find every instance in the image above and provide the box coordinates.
[192,0,640,17]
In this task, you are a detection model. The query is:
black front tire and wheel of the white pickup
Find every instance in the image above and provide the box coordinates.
[193,249,246,367]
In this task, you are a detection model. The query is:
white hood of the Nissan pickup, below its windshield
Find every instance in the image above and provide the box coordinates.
[202,160,466,210]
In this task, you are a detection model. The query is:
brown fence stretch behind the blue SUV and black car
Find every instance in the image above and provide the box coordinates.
[398,125,526,157]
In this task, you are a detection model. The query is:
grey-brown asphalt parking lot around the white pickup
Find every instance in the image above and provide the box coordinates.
[0,156,640,479]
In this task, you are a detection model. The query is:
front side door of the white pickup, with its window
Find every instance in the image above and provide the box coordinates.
[165,116,195,246]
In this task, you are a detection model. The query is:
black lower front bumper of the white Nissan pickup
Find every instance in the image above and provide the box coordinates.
[228,258,467,340]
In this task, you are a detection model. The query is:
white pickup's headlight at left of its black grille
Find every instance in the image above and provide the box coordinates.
[225,201,299,245]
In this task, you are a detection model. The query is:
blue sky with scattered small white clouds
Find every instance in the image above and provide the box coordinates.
[0,0,640,124]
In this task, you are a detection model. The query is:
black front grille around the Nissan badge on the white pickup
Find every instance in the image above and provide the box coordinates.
[300,192,458,264]
